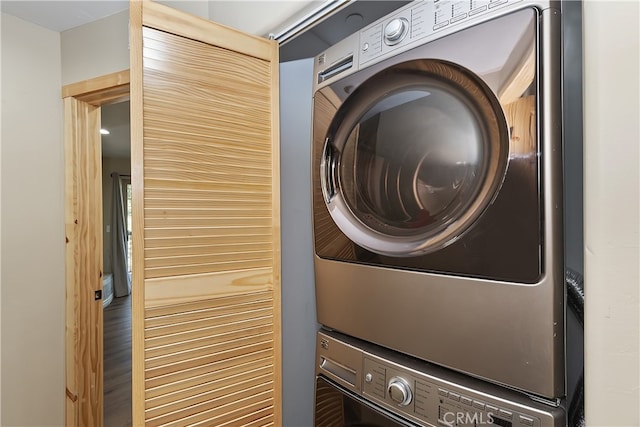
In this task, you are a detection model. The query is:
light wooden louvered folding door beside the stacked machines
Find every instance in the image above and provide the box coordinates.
[130,1,281,426]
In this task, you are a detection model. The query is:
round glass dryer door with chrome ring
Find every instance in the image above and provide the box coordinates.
[320,60,509,257]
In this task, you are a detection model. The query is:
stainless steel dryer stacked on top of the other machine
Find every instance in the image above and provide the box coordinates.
[312,0,565,399]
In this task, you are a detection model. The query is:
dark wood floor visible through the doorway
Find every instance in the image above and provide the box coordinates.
[104,295,131,427]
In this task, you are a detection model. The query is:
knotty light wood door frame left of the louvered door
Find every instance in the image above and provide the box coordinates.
[62,70,130,427]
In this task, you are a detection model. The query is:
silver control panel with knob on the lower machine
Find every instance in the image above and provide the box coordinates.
[316,331,565,427]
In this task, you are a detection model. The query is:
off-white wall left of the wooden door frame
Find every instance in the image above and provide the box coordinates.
[0,13,65,426]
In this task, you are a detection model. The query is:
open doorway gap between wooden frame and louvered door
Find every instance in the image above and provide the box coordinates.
[100,101,133,427]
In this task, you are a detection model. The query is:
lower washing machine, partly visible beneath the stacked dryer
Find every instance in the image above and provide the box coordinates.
[314,330,566,427]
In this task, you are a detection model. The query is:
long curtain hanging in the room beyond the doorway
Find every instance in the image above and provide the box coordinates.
[111,172,131,298]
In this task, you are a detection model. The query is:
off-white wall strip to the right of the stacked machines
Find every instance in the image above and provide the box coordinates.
[583,1,640,426]
